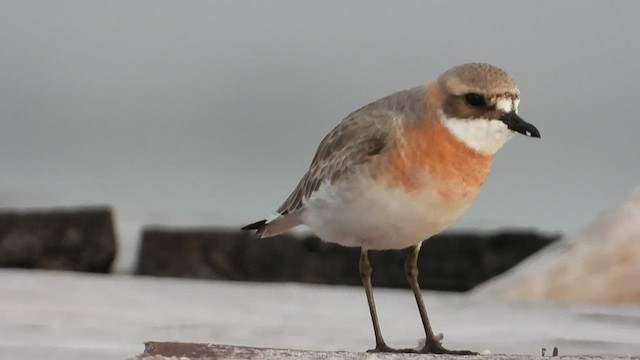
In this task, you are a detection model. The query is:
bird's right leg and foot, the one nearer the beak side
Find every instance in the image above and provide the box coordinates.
[404,244,477,355]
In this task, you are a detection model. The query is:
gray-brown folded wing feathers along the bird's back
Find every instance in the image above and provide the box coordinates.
[278,88,424,214]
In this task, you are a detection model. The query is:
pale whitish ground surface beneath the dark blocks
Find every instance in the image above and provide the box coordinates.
[0,269,640,360]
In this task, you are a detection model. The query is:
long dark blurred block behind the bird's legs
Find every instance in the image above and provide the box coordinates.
[136,227,558,291]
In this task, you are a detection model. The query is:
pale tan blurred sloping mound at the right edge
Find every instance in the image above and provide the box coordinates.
[475,187,640,304]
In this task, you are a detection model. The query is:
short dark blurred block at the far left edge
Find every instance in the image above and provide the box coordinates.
[0,207,116,273]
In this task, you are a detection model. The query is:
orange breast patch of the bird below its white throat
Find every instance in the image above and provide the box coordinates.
[386,116,493,200]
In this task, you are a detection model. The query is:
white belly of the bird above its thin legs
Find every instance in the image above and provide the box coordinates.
[302,181,470,250]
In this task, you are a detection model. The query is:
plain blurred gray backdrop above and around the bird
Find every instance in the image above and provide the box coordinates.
[0,0,640,236]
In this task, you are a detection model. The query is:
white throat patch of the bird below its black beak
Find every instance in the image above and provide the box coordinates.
[438,111,515,155]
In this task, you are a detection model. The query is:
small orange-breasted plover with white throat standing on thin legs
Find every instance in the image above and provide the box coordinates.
[242,63,540,355]
